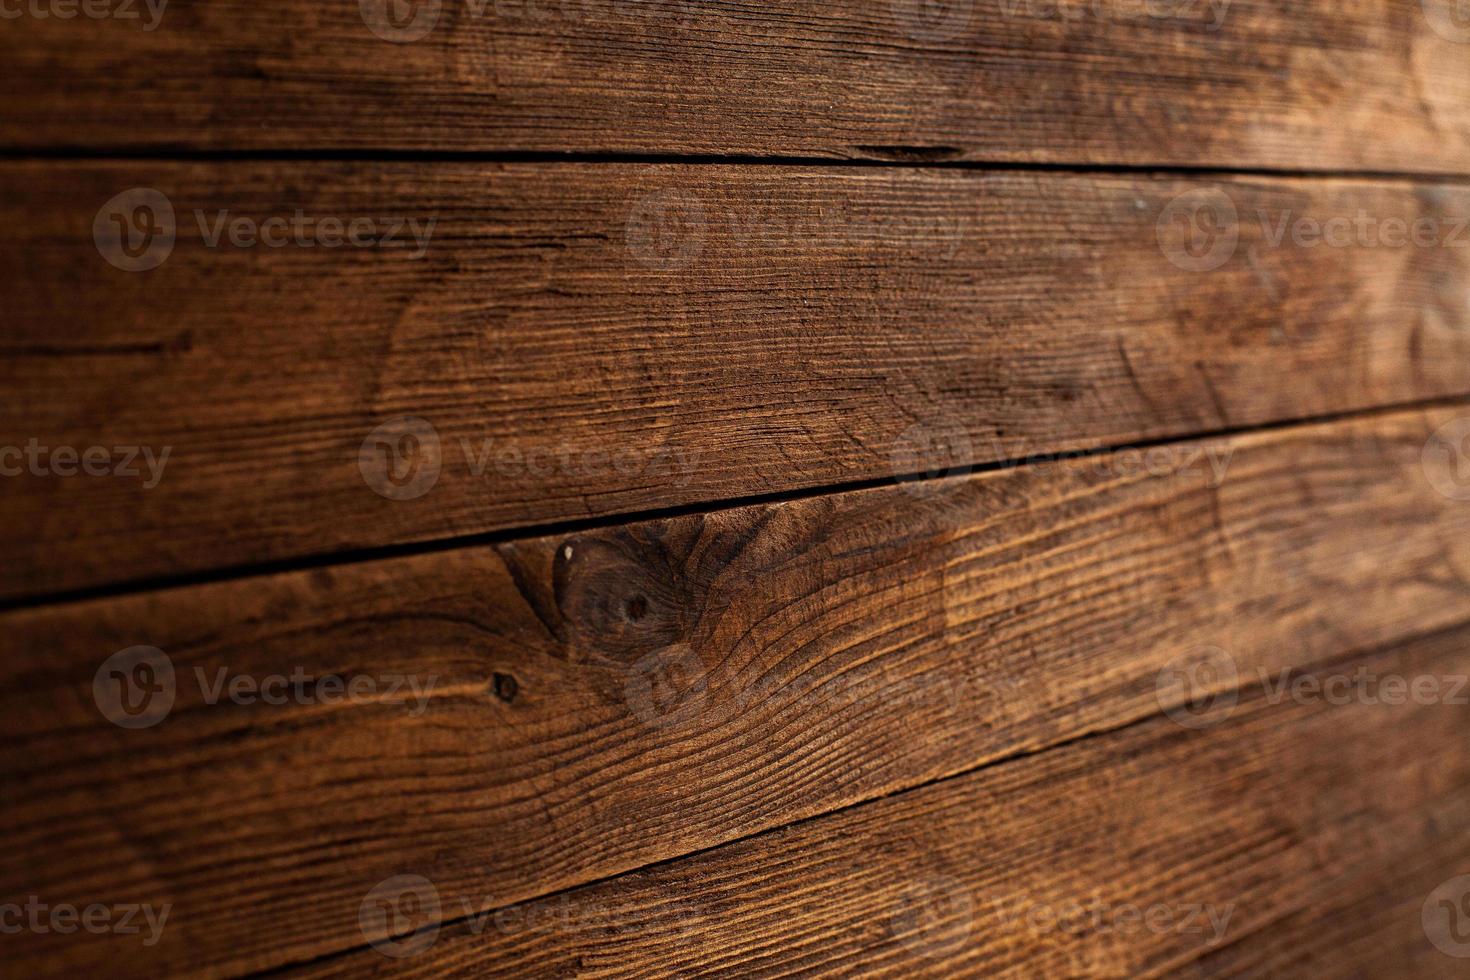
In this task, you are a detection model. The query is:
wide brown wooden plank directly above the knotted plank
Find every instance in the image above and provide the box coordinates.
[0,163,1470,598]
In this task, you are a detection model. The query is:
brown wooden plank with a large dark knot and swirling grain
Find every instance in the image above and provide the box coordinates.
[0,410,1470,974]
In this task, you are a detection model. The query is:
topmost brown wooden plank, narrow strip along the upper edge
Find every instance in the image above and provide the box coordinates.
[0,0,1470,173]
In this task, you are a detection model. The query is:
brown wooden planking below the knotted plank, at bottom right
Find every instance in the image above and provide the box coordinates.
[294,629,1470,980]
